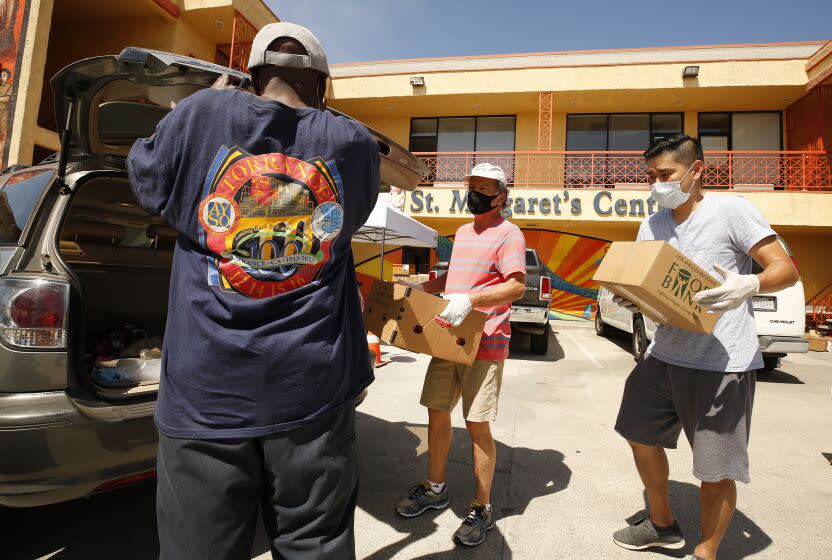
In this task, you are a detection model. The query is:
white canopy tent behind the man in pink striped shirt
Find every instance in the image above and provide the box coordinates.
[352,199,437,279]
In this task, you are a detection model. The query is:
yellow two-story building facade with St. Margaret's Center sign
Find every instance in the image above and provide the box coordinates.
[331,42,832,319]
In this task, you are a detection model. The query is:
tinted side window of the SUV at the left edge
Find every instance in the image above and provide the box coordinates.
[0,169,54,245]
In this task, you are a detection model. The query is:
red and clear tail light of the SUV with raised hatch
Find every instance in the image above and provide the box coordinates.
[0,278,69,348]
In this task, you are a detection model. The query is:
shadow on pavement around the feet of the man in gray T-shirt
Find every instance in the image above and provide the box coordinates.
[626,480,772,560]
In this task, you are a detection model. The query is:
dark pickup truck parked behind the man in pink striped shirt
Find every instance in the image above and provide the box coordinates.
[431,248,552,355]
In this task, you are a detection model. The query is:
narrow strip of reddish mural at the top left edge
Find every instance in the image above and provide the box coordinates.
[0,0,30,168]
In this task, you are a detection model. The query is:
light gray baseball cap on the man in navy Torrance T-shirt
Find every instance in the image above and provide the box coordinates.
[248,21,329,76]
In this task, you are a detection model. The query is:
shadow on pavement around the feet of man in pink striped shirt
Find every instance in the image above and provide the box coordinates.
[357,412,572,560]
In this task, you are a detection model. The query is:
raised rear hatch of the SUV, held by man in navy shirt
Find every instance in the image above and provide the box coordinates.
[50,47,427,189]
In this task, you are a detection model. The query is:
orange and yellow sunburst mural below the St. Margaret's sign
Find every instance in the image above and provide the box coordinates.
[356,229,610,321]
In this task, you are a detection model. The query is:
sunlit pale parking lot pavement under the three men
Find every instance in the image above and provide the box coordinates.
[0,325,832,560]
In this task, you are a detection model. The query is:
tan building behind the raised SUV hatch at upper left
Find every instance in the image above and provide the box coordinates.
[0,0,278,168]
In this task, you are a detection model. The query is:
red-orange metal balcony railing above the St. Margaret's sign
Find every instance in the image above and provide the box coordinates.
[415,150,832,192]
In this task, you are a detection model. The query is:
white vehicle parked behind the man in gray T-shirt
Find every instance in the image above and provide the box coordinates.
[595,239,809,372]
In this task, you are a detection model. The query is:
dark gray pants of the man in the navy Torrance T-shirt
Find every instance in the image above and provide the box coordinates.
[156,405,358,560]
